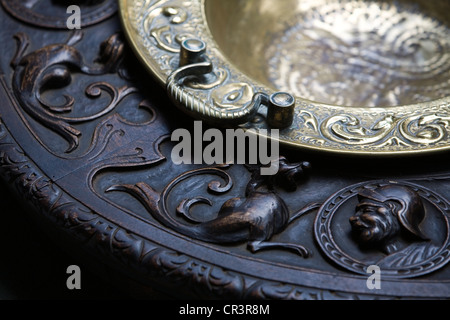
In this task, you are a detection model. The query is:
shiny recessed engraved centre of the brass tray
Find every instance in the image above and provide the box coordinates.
[207,0,450,107]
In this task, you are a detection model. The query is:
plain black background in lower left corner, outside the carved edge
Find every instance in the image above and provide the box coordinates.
[0,180,129,300]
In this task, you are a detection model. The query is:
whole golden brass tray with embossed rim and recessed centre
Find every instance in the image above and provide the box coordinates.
[119,0,450,156]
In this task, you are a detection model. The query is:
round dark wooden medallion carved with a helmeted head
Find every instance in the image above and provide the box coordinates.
[315,181,450,278]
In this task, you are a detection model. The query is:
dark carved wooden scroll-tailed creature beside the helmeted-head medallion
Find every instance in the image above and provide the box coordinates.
[107,158,319,258]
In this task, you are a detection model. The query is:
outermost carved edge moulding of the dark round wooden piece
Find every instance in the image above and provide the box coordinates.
[0,110,448,300]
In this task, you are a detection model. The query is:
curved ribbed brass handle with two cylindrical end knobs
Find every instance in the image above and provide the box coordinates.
[166,38,295,128]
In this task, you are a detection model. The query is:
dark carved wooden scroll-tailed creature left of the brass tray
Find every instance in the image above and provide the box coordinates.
[11,32,136,153]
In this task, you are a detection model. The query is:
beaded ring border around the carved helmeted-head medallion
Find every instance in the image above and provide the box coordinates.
[314,180,450,278]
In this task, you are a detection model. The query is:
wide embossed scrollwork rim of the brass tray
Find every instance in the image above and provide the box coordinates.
[119,0,450,156]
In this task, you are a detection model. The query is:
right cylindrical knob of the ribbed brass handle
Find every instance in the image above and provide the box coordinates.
[267,92,295,129]
